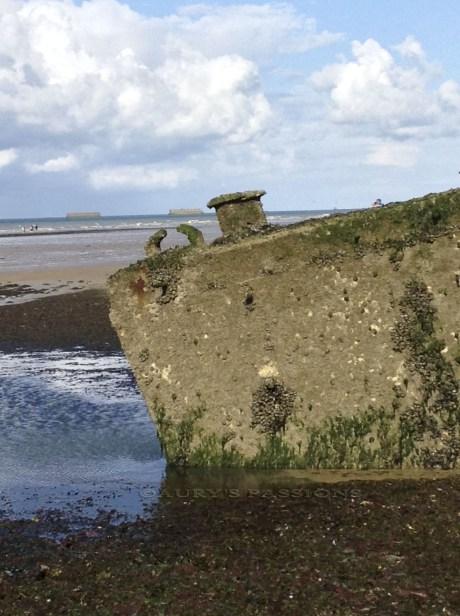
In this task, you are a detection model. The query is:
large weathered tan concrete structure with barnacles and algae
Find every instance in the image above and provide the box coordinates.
[109,189,460,468]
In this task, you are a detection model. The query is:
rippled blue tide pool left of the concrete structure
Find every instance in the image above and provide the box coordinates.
[0,349,165,528]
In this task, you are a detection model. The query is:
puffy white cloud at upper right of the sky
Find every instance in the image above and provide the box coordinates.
[312,37,448,136]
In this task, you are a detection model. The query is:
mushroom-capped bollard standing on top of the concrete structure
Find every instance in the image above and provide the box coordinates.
[208,190,267,235]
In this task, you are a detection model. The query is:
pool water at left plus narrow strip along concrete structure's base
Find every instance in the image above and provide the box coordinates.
[0,349,460,536]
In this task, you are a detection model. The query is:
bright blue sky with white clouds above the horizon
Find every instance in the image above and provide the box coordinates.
[0,0,460,218]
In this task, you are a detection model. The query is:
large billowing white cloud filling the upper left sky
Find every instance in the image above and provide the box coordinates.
[0,0,282,145]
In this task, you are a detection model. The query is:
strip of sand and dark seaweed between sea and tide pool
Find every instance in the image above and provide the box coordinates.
[0,249,120,351]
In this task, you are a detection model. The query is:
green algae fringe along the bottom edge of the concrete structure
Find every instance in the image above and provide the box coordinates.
[152,407,401,470]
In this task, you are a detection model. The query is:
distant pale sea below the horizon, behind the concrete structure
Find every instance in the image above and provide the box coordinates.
[0,210,334,274]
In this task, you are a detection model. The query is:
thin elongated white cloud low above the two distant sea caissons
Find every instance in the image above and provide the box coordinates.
[90,165,195,190]
